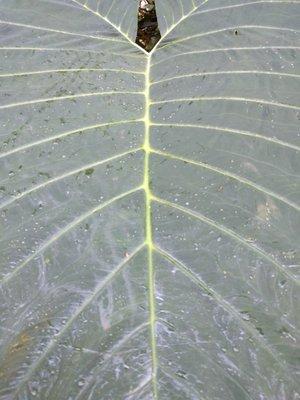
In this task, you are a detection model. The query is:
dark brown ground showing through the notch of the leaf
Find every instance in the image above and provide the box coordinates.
[136,0,160,51]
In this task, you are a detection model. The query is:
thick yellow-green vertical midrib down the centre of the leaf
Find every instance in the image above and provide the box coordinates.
[143,54,158,399]
